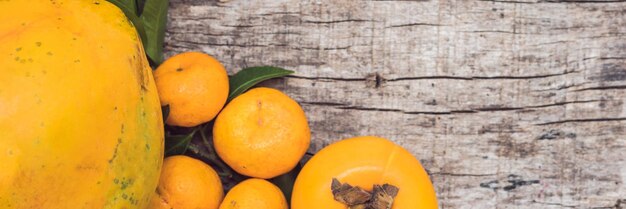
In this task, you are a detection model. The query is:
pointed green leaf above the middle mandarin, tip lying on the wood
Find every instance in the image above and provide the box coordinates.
[228,66,293,101]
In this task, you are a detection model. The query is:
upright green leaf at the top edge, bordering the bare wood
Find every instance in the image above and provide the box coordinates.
[140,0,169,65]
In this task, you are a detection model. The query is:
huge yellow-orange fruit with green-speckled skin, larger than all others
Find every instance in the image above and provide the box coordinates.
[0,0,163,209]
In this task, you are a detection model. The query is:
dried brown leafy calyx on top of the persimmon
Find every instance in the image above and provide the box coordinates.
[331,178,400,209]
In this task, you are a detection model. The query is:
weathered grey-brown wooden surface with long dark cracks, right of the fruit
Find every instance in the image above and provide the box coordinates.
[166,0,626,208]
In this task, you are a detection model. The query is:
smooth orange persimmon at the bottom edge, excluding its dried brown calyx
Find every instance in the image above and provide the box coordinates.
[291,136,437,209]
